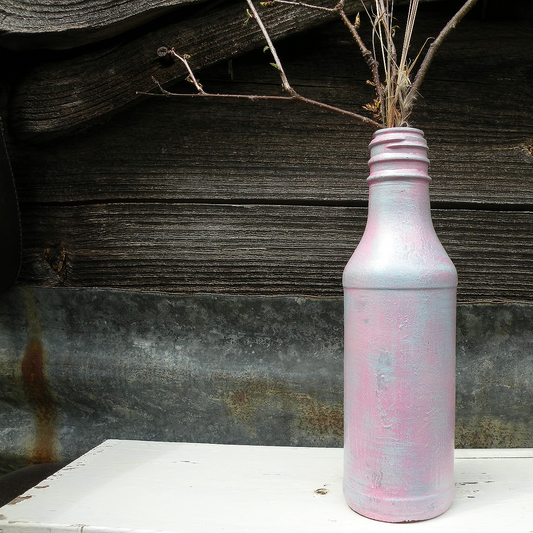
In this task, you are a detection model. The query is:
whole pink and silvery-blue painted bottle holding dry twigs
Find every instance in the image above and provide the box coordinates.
[343,128,457,522]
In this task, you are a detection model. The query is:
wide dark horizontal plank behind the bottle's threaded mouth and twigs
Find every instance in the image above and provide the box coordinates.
[14,5,533,209]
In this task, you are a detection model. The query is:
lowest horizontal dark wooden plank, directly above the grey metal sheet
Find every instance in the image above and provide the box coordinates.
[16,203,533,302]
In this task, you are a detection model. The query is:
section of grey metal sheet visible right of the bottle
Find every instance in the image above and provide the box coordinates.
[455,304,533,448]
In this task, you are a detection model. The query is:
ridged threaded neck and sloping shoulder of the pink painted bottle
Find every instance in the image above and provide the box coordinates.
[343,128,457,288]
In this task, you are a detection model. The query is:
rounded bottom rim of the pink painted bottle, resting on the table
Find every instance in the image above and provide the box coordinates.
[344,488,453,523]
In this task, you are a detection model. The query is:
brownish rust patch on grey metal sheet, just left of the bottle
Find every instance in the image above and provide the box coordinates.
[221,378,343,442]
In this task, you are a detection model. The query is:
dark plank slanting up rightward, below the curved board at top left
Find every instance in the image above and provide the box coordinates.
[10,0,359,137]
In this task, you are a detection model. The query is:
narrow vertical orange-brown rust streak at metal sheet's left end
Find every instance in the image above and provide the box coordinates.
[21,290,57,464]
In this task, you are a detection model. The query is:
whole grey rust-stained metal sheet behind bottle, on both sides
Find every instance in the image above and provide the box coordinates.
[0,288,533,472]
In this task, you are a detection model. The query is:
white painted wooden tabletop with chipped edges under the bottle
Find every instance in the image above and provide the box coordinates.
[0,440,533,533]
